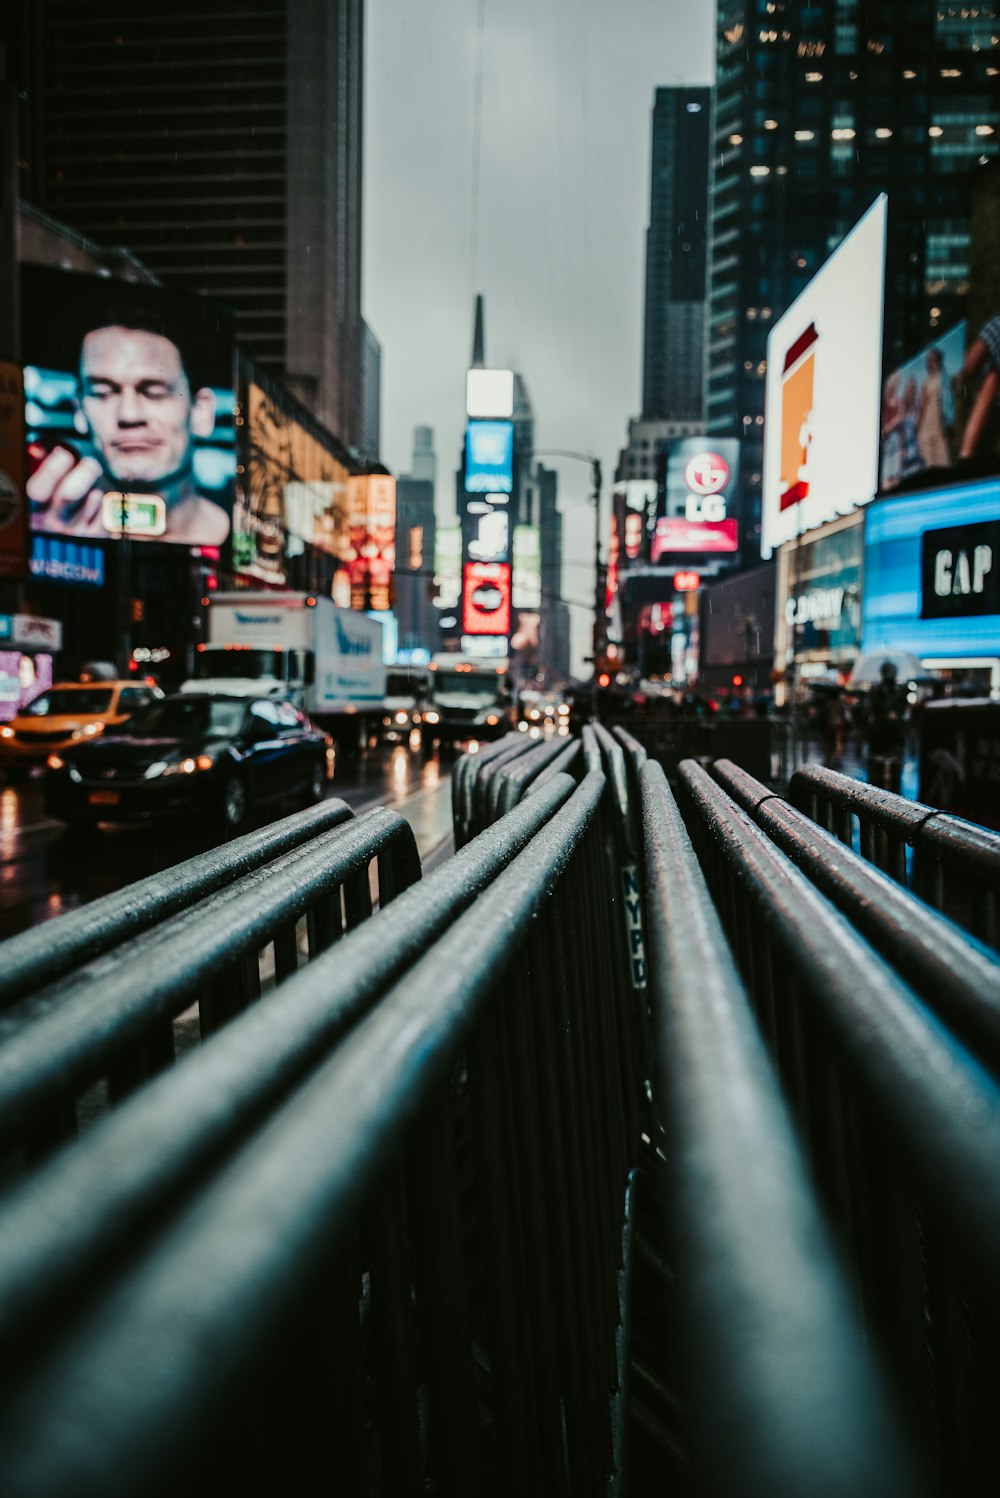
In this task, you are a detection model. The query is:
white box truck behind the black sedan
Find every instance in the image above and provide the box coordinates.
[183,592,386,745]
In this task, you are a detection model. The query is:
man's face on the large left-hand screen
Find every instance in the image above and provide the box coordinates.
[79,327,216,485]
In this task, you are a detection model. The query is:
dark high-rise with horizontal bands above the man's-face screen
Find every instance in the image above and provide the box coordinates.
[19,0,364,446]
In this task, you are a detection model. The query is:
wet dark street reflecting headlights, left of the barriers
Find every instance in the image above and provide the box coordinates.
[0,746,451,938]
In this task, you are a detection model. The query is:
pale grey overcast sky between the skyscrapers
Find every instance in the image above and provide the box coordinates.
[364,0,714,670]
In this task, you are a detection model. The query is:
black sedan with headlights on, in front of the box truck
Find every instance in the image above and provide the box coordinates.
[45,692,329,831]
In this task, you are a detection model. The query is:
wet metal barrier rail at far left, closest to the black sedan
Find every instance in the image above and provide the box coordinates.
[0,800,353,1008]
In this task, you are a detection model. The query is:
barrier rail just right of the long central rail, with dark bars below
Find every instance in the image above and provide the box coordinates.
[681,762,1000,1498]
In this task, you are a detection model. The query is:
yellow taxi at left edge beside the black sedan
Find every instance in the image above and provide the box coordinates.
[0,680,163,776]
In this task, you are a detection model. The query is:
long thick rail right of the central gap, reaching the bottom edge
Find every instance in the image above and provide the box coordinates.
[639,764,919,1498]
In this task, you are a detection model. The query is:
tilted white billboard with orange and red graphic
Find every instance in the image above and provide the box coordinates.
[760,196,886,557]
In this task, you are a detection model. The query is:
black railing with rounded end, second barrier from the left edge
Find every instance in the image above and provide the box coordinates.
[0,806,419,1174]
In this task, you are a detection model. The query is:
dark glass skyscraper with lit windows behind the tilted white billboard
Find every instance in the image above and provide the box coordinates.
[707,0,1000,545]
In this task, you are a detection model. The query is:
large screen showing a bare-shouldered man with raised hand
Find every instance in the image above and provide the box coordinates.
[21,265,237,547]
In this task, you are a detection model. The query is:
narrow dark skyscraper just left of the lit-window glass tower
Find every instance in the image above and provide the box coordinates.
[642,88,711,421]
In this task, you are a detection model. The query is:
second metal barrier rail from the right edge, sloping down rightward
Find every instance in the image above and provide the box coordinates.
[713,759,1000,1076]
